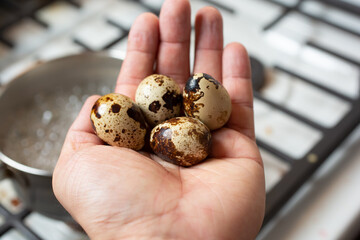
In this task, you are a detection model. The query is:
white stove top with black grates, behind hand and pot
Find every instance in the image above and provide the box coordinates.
[0,0,360,239]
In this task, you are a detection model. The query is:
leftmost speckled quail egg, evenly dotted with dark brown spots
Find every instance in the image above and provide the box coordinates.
[90,93,147,150]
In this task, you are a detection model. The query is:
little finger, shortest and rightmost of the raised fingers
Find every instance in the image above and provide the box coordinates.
[223,43,255,140]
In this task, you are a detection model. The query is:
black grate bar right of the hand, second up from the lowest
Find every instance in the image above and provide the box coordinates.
[254,92,327,132]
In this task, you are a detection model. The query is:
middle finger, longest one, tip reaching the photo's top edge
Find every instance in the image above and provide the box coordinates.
[157,0,191,85]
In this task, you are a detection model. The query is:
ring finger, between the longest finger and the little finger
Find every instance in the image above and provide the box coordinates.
[194,7,223,82]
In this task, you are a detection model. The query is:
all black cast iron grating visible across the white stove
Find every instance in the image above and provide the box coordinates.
[0,0,360,239]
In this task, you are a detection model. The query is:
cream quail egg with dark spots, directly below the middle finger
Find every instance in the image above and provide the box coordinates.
[135,74,182,127]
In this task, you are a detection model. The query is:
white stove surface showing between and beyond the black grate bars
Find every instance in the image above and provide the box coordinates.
[0,0,360,240]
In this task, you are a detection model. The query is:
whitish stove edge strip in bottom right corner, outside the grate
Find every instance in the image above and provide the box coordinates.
[258,127,360,240]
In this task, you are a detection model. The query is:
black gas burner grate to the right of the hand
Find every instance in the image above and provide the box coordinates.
[254,0,360,226]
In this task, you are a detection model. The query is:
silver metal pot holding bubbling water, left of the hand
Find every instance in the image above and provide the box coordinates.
[0,52,122,222]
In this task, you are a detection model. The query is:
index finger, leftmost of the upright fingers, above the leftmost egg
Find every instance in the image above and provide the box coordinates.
[115,13,159,99]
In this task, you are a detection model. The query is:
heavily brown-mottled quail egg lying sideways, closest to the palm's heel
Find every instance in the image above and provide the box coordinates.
[150,117,211,167]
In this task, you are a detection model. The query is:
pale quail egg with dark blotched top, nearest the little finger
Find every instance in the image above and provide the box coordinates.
[183,73,231,130]
